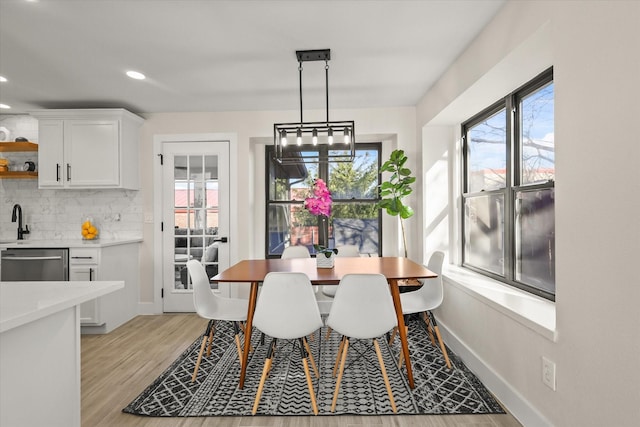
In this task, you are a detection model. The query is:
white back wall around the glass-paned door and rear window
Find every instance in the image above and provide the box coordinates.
[140,107,422,303]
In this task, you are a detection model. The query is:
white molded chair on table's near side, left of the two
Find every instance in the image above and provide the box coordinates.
[252,272,322,415]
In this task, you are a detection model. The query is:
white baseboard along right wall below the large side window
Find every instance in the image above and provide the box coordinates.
[436,318,553,427]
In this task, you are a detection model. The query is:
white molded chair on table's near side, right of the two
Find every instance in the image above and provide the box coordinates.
[327,274,398,412]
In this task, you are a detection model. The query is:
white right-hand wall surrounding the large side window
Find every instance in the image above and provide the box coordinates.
[417,1,640,427]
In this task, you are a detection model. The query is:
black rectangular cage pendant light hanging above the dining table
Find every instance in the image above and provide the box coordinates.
[273,49,356,164]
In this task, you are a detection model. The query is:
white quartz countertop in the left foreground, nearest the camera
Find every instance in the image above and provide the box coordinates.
[0,280,124,333]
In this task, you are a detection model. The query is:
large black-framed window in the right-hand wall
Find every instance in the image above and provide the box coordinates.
[462,69,555,300]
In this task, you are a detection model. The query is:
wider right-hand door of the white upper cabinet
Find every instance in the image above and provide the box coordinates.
[64,120,120,188]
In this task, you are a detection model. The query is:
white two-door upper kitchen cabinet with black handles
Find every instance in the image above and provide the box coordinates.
[31,109,143,189]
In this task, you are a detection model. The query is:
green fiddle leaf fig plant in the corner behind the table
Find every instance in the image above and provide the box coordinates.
[376,150,416,257]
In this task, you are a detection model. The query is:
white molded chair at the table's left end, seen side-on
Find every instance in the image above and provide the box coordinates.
[187,259,249,382]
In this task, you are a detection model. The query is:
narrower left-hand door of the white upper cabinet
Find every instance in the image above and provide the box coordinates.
[38,120,65,188]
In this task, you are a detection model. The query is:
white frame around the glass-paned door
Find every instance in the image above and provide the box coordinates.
[152,133,239,314]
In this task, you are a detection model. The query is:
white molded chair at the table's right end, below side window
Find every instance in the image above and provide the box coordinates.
[400,251,451,369]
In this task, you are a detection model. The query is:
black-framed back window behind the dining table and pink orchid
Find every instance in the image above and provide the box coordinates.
[265,143,382,258]
